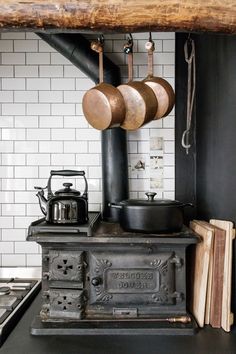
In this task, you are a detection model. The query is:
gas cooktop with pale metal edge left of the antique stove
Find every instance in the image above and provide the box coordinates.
[0,268,41,346]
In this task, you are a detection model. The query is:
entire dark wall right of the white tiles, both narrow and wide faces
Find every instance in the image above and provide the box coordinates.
[176,34,236,320]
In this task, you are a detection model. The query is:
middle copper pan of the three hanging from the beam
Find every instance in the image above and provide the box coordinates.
[117,37,157,130]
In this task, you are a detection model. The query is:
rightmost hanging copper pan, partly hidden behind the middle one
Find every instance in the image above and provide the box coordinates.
[143,34,175,119]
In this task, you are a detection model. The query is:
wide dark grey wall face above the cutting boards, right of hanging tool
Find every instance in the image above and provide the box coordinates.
[196,35,236,222]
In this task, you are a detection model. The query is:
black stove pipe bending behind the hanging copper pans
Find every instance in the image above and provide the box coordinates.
[37,32,129,221]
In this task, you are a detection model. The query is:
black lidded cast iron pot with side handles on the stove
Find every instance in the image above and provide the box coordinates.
[110,192,192,233]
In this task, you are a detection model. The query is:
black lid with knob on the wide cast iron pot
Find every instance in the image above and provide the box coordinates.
[120,192,183,206]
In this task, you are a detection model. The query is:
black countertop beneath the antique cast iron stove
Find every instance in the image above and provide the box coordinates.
[0,294,236,354]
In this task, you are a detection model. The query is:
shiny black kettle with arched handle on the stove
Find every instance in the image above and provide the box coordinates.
[34,170,88,224]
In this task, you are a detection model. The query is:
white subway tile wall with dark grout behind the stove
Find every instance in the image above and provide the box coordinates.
[0,32,175,266]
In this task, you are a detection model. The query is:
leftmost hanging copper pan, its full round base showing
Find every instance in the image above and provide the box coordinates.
[82,36,125,130]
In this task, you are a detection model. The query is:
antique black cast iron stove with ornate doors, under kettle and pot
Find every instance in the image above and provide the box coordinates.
[27,213,197,335]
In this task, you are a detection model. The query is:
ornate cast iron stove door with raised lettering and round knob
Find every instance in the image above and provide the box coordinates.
[89,251,183,307]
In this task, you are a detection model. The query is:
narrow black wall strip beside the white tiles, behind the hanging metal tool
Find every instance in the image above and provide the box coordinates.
[175,34,197,224]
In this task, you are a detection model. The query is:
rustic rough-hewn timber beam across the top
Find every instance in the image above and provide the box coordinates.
[0,0,236,34]
